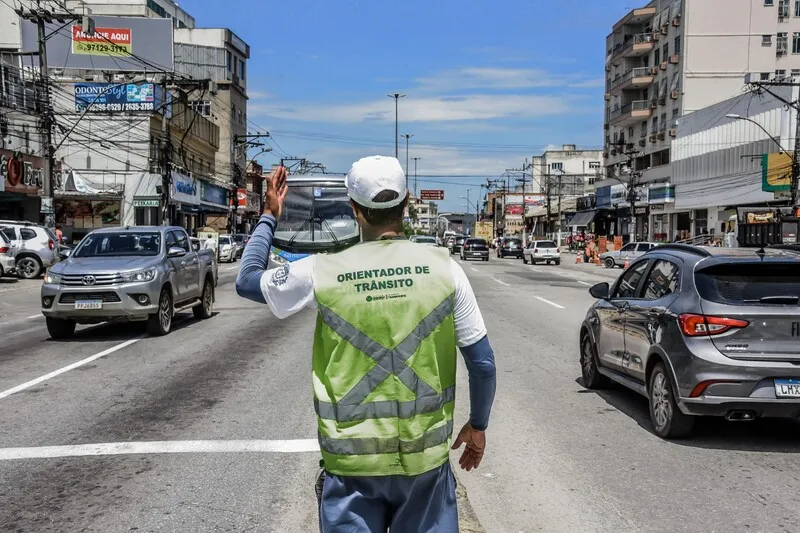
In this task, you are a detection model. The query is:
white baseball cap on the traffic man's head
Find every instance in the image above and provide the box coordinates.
[345,155,406,209]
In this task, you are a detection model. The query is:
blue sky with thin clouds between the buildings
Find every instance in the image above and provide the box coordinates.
[181,0,638,210]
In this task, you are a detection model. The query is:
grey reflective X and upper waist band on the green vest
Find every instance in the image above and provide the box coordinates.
[314,296,455,422]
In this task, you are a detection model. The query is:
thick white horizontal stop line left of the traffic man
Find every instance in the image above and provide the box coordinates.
[0,439,319,461]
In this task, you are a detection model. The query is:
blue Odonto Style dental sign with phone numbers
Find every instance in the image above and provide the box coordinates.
[73,83,161,113]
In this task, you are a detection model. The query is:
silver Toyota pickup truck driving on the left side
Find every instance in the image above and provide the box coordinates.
[41,226,217,339]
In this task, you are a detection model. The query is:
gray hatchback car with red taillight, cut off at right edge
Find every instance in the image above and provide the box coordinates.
[580,244,800,438]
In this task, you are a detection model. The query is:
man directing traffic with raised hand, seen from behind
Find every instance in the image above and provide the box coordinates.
[236,156,495,533]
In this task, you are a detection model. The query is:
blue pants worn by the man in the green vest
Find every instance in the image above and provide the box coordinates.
[320,462,458,533]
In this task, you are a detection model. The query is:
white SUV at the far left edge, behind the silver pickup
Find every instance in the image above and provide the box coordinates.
[0,220,58,279]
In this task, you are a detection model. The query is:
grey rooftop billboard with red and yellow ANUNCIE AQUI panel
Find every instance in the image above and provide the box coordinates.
[21,17,174,72]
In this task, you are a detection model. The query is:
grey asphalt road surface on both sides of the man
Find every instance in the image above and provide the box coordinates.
[0,256,800,533]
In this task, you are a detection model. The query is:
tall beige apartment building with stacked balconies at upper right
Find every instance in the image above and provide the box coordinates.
[598,0,800,242]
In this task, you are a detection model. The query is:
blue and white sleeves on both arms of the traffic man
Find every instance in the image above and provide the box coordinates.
[236,215,497,431]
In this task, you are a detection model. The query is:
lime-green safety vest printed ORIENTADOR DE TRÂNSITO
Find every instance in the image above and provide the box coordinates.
[312,240,456,476]
